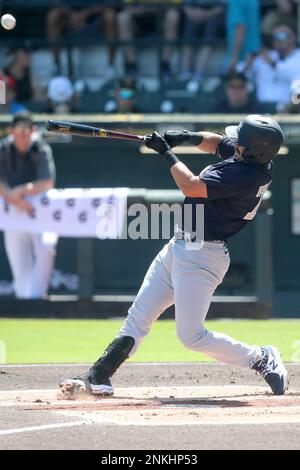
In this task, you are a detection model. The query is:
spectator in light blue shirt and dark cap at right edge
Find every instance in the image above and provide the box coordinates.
[247,24,300,111]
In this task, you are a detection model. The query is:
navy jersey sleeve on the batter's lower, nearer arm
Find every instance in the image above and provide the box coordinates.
[201,163,253,199]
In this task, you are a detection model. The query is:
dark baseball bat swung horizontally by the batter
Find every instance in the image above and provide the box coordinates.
[46,119,144,141]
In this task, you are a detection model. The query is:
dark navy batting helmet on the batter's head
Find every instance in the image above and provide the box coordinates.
[225,114,284,163]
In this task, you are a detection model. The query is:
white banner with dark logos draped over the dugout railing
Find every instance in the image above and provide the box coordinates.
[0,188,129,239]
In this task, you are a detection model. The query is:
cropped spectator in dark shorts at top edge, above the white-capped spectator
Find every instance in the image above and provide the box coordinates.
[47,0,116,75]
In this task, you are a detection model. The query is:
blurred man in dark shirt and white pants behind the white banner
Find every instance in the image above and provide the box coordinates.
[0,112,57,299]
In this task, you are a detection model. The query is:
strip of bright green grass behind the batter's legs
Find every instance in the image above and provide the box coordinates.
[0,319,300,364]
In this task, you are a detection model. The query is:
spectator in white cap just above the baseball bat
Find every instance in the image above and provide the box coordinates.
[46,77,75,114]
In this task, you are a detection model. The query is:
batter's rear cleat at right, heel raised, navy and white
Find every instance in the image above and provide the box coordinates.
[251,346,288,395]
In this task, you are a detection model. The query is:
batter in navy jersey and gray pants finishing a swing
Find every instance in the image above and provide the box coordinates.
[60,115,287,398]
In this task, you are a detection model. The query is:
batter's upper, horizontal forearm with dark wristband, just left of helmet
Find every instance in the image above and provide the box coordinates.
[163,131,222,155]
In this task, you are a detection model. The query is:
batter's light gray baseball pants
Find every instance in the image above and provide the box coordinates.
[119,238,261,367]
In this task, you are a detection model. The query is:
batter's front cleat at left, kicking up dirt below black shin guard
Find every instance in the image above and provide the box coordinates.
[59,372,114,400]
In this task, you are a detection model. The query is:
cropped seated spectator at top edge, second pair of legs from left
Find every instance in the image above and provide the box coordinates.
[118,0,180,78]
